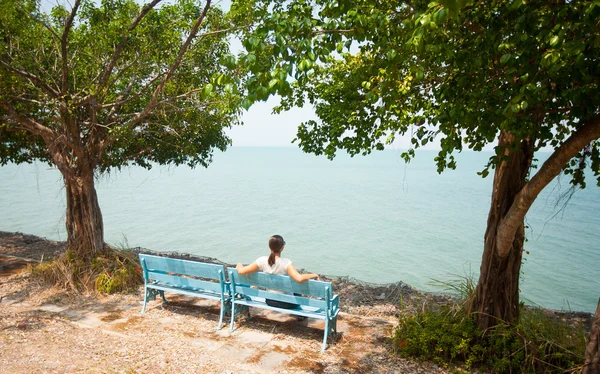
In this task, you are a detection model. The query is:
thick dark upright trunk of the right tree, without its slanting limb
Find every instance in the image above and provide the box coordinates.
[472,132,533,330]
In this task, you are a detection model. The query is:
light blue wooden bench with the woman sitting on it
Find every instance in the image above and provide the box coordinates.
[229,269,339,351]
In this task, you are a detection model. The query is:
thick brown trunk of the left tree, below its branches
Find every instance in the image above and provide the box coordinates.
[64,168,104,261]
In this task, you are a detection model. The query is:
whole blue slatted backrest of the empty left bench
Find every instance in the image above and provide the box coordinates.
[139,253,225,293]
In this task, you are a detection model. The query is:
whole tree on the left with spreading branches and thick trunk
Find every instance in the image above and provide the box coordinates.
[0,0,242,260]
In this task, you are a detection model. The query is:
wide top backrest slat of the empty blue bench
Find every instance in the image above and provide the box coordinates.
[139,253,225,280]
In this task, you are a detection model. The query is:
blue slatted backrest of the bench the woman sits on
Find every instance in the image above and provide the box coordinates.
[229,269,333,309]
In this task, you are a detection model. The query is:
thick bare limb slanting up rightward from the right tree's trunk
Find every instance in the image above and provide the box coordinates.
[496,115,600,257]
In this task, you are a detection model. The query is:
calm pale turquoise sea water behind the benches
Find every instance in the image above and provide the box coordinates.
[0,147,600,312]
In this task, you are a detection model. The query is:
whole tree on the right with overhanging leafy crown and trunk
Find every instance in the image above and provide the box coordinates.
[234,0,600,329]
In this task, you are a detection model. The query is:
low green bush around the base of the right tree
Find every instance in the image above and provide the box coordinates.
[393,303,585,373]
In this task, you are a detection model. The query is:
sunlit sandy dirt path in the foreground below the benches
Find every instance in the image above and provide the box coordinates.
[0,259,444,373]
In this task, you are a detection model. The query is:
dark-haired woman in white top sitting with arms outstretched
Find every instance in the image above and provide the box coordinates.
[235,235,319,309]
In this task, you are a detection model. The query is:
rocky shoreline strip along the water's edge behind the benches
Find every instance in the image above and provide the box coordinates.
[0,231,593,331]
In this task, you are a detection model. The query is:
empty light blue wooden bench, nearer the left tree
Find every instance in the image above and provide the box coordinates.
[139,253,230,329]
